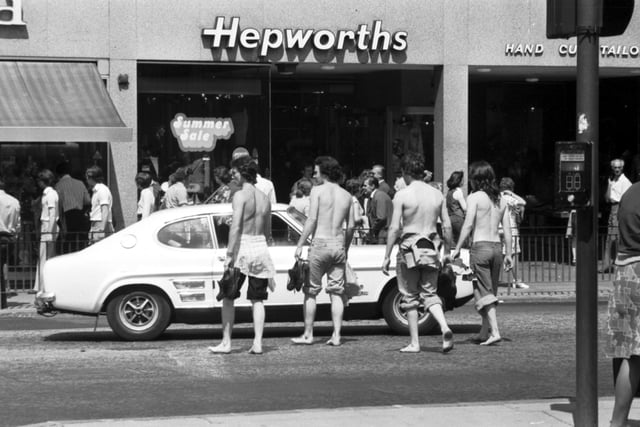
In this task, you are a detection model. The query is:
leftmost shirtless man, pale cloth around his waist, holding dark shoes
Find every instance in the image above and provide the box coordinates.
[209,156,275,354]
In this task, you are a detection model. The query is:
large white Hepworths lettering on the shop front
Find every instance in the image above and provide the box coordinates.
[202,16,408,56]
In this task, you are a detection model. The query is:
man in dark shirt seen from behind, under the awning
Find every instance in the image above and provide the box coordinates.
[56,162,91,253]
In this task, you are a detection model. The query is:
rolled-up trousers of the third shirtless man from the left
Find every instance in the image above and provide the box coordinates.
[396,251,442,310]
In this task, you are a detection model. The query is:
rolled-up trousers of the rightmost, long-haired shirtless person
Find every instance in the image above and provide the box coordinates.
[469,242,502,311]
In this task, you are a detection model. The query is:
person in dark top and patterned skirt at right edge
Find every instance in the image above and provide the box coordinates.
[605,183,640,427]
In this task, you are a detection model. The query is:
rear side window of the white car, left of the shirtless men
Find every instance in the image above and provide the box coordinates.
[158,217,213,249]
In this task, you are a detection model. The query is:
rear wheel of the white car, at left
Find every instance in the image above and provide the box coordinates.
[107,290,171,341]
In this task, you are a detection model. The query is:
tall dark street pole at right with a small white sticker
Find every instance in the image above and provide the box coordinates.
[575,0,600,427]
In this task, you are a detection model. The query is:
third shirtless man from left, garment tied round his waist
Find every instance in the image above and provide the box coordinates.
[382,153,453,353]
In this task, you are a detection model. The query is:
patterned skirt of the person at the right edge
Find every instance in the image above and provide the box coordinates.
[605,262,640,359]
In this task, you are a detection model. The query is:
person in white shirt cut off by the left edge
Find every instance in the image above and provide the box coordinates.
[0,177,20,308]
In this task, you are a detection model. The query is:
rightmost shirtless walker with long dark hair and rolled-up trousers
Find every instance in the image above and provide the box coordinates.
[452,161,513,345]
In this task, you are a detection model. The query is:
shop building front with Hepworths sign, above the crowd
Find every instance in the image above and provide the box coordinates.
[0,0,640,226]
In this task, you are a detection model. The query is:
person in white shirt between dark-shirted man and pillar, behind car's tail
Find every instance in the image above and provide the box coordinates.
[86,166,113,243]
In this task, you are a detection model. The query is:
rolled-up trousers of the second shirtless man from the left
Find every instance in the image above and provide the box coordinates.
[302,237,347,296]
